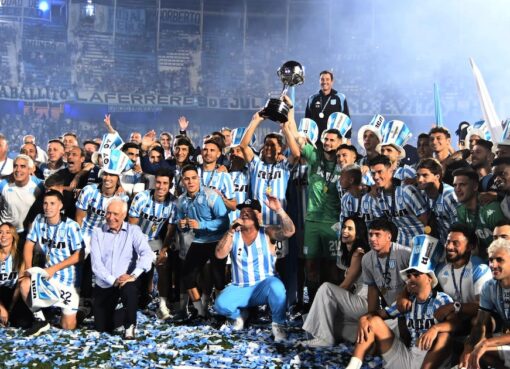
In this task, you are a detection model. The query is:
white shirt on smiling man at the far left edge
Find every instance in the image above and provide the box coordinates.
[0,176,44,233]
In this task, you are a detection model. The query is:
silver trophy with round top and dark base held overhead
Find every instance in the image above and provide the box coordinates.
[261,60,305,123]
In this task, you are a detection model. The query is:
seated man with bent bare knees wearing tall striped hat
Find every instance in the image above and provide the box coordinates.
[346,253,458,369]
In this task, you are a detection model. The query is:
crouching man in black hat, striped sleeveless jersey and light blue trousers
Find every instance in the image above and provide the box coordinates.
[214,195,295,342]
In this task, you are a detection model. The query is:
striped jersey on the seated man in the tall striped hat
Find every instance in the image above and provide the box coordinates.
[386,292,453,347]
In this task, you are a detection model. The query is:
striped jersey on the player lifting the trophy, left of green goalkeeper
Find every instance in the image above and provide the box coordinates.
[249,155,291,225]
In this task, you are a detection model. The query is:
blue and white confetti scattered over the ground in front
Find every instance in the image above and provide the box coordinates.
[0,313,382,369]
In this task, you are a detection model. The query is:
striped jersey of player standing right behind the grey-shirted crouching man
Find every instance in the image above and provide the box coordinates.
[375,185,427,247]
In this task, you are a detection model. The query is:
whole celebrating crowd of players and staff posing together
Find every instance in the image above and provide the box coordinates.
[0,71,510,369]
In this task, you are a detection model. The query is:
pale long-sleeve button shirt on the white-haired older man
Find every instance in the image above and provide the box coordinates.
[90,222,154,288]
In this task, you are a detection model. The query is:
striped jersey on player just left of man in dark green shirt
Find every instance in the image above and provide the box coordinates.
[421,183,458,245]
